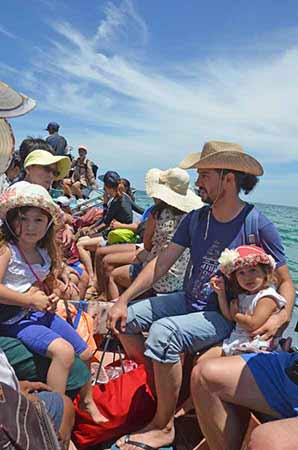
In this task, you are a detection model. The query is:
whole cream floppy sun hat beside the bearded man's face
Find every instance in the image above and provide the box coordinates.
[146,167,203,212]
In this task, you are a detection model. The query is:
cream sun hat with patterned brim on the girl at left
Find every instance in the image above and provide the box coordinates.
[0,181,64,227]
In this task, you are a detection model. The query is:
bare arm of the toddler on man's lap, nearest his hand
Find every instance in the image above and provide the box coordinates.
[235,297,277,331]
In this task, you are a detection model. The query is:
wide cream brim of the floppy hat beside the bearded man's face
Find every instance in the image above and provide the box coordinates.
[146,169,203,213]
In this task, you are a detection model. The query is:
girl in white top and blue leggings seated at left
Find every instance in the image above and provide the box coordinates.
[0,182,105,422]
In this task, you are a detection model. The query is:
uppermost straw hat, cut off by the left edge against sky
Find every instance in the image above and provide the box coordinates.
[0,81,36,117]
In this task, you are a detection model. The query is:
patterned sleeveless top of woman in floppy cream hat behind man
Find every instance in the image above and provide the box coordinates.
[147,209,190,293]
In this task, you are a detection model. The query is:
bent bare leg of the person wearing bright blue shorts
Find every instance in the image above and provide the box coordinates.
[191,356,276,450]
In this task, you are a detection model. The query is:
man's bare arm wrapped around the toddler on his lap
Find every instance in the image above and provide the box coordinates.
[252,265,296,339]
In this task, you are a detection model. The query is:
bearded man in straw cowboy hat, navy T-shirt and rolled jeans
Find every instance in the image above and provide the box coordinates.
[108,142,295,450]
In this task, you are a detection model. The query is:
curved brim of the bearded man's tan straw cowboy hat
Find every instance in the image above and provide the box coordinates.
[179,150,264,176]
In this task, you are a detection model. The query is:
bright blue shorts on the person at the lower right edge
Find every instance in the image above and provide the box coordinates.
[241,352,298,419]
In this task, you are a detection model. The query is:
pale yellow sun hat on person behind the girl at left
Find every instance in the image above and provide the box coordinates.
[24,149,71,180]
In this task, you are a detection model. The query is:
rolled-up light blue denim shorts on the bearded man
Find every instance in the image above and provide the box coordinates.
[125,292,233,364]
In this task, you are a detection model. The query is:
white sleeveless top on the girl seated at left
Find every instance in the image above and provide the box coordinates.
[0,243,51,323]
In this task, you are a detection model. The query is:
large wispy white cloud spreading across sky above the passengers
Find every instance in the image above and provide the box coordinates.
[10,0,298,197]
